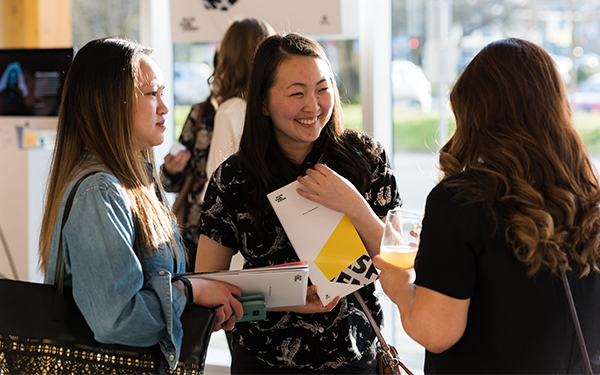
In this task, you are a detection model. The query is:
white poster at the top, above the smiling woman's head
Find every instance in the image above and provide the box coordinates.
[171,0,341,43]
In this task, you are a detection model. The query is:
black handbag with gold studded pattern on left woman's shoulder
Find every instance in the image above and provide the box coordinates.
[0,172,216,375]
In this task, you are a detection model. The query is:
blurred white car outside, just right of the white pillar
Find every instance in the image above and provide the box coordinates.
[392,60,432,112]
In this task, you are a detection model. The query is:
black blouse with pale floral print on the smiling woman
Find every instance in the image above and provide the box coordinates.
[199,131,401,371]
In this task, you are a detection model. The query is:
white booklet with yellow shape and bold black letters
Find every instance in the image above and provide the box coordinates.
[267,181,378,305]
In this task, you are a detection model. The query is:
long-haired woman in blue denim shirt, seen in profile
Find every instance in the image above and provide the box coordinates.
[40,38,242,369]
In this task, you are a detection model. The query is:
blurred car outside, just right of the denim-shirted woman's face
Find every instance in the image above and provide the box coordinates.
[173,62,212,105]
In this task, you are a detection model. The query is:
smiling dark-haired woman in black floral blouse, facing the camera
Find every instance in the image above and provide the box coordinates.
[196,34,401,374]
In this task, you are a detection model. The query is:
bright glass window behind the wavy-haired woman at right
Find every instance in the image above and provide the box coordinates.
[390,0,600,373]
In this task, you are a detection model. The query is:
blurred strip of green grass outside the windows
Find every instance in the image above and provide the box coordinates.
[174,104,600,155]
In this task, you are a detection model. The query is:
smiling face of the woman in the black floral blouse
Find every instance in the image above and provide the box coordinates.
[263,56,334,162]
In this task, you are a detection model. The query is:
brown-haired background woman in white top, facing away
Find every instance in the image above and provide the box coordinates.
[206,18,275,180]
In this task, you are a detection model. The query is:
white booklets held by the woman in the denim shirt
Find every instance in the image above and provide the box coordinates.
[185,262,308,307]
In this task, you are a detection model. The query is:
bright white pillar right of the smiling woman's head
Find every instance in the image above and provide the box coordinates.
[359,0,394,160]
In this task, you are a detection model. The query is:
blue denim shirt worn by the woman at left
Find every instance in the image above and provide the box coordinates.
[45,173,186,369]
